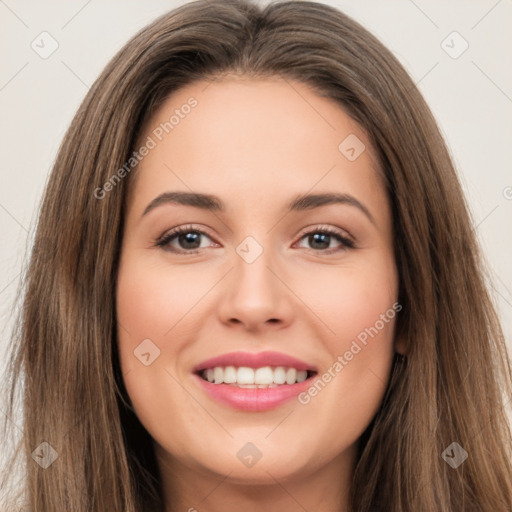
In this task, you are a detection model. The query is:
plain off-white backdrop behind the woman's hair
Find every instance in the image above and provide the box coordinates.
[0,0,512,476]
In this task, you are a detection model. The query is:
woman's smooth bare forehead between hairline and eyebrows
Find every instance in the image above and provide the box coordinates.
[128,77,384,225]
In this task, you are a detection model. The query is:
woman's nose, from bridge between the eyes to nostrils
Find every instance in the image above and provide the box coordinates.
[219,243,296,332]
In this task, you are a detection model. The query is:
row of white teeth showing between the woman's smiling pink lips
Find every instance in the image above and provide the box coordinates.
[201,366,308,388]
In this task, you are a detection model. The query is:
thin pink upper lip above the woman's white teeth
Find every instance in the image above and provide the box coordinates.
[193,351,316,373]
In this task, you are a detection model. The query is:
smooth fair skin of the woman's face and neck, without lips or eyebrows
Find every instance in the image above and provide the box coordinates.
[115,76,403,512]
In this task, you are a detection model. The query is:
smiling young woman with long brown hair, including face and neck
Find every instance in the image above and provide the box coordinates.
[1,0,512,512]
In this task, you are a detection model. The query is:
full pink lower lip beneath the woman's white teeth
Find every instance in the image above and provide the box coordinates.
[194,374,313,411]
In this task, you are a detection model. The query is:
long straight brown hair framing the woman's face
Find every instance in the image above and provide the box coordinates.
[2,0,512,512]
